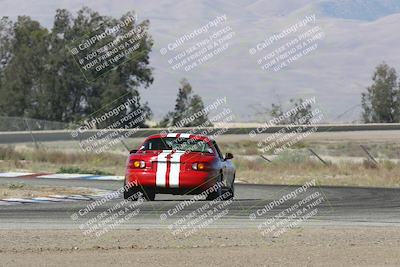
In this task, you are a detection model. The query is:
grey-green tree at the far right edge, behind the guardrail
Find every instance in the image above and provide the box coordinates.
[361,63,400,123]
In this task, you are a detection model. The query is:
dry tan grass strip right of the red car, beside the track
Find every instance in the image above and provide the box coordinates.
[235,153,400,187]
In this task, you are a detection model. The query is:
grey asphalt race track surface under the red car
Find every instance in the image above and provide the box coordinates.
[0,178,400,229]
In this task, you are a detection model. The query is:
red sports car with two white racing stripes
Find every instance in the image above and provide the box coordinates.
[124,133,235,200]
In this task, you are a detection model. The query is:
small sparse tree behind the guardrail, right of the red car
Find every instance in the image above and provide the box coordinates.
[269,98,312,124]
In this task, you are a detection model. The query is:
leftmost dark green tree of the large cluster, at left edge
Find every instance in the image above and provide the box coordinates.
[0,16,48,116]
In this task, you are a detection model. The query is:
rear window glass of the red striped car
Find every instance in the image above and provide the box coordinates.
[140,137,213,153]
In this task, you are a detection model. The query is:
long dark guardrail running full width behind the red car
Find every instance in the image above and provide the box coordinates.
[0,123,400,144]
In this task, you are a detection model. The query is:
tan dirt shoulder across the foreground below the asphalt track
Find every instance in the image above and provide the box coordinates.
[0,227,400,266]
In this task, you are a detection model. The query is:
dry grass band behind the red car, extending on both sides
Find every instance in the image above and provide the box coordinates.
[0,144,400,187]
